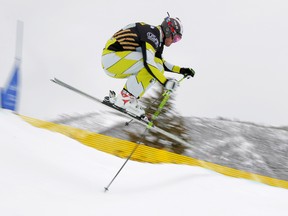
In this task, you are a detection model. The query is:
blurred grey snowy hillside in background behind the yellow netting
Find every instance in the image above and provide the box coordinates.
[54,111,288,181]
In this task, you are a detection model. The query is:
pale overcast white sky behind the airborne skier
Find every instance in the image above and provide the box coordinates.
[0,0,288,125]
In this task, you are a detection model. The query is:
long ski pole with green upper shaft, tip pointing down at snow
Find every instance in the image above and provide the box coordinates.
[104,76,190,192]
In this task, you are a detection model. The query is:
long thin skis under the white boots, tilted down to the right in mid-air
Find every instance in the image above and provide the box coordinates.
[51,78,190,147]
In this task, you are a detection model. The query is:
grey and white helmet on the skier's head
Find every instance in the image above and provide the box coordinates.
[161,16,183,42]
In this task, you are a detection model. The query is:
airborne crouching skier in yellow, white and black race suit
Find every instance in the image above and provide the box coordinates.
[102,14,195,117]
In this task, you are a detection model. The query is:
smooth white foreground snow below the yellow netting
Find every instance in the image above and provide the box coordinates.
[0,110,288,216]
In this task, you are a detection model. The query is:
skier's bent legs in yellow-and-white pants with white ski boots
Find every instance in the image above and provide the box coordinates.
[102,49,164,116]
